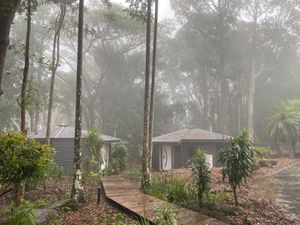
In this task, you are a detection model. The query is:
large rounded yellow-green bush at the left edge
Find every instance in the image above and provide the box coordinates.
[0,132,53,188]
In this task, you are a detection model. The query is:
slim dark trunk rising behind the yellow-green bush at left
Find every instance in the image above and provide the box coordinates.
[21,0,31,134]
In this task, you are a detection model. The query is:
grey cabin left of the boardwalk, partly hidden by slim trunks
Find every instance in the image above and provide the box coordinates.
[31,124,121,171]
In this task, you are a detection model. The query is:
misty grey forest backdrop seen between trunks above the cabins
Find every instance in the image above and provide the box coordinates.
[0,0,300,149]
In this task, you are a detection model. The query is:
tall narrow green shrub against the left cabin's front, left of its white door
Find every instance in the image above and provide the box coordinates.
[86,127,103,173]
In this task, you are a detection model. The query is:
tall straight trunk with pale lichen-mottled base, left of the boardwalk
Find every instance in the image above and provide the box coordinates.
[71,0,85,205]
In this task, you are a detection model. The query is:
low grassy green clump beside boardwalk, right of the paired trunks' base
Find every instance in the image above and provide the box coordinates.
[146,175,196,203]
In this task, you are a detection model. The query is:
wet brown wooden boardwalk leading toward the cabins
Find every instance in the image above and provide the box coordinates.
[102,176,225,225]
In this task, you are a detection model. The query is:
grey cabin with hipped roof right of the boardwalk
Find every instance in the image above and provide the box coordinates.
[152,128,230,171]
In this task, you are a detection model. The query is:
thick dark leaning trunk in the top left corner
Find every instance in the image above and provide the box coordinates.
[0,0,21,96]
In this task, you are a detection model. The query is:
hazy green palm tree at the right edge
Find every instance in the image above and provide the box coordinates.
[268,100,300,156]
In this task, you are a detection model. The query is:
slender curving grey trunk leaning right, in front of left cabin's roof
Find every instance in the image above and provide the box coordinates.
[46,3,66,145]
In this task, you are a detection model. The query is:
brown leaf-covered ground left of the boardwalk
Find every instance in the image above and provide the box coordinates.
[0,178,136,225]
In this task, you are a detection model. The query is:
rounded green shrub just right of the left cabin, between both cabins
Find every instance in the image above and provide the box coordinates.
[110,142,128,174]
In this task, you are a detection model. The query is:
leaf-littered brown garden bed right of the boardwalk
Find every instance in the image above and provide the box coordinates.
[150,158,300,225]
